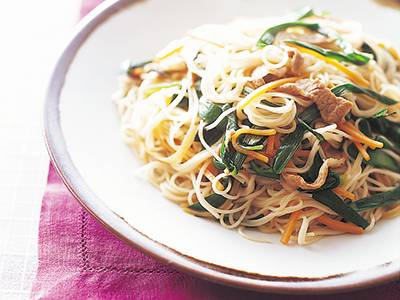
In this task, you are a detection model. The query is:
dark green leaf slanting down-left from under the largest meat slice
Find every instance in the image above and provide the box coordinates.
[272,105,320,174]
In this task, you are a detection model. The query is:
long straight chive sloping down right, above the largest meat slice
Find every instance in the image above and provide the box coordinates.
[286,40,370,65]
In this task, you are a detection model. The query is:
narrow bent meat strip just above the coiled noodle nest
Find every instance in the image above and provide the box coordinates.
[250,48,304,89]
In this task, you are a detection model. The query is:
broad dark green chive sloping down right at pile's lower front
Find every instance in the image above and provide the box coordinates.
[312,190,369,229]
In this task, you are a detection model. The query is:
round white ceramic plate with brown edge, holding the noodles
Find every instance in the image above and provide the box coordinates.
[45,0,400,293]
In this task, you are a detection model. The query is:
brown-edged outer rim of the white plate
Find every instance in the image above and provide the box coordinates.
[43,0,400,294]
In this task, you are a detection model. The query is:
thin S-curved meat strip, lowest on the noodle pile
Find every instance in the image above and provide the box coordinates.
[281,158,344,190]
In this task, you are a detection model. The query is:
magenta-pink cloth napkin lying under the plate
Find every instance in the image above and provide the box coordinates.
[32,0,400,300]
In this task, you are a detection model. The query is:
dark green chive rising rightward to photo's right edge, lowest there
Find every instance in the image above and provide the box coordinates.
[351,186,400,211]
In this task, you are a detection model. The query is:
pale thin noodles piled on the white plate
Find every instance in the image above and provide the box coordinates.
[113,12,400,245]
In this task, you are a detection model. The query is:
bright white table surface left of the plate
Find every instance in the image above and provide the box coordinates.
[0,0,80,300]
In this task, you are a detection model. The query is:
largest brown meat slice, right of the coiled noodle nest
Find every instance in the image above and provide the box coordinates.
[277,79,353,124]
